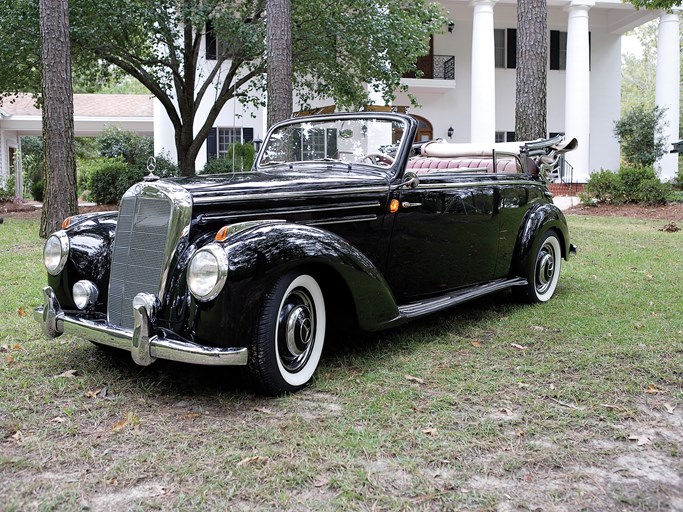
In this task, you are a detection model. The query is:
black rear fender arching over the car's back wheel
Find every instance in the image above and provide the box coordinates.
[513,203,571,275]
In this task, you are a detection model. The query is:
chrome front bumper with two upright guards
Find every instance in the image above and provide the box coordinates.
[33,286,247,366]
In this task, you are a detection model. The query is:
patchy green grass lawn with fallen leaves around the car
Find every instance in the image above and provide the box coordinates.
[0,216,683,511]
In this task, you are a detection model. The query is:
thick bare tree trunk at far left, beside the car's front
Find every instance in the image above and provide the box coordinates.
[40,0,78,238]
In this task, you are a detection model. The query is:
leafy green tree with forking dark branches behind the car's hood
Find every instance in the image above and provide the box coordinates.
[0,0,446,175]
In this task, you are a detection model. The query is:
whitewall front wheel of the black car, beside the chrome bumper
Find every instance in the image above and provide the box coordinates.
[249,272,326,395]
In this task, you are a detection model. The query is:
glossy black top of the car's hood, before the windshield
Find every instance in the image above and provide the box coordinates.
[169,164,390,209]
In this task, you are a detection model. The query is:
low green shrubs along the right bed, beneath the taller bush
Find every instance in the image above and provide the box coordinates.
[581,167,672,205]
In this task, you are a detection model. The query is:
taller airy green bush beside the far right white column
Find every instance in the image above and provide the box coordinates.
[614,105,666,167]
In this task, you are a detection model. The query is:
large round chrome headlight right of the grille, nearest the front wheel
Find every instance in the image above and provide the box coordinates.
[187,244,228,301]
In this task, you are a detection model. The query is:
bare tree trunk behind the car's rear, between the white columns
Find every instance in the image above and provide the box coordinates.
[515,0,548,141]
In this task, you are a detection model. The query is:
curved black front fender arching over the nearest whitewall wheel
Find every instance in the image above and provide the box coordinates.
[191,223,399,344]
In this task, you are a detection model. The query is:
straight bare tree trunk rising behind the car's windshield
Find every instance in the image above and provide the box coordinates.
[266,0,293,126]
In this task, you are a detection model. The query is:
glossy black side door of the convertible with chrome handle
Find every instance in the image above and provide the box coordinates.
[387,171,499,303]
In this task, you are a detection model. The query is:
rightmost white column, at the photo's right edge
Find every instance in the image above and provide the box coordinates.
[655,8,681,180]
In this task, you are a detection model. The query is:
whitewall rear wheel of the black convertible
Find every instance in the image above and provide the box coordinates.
[524,231,562,302]
